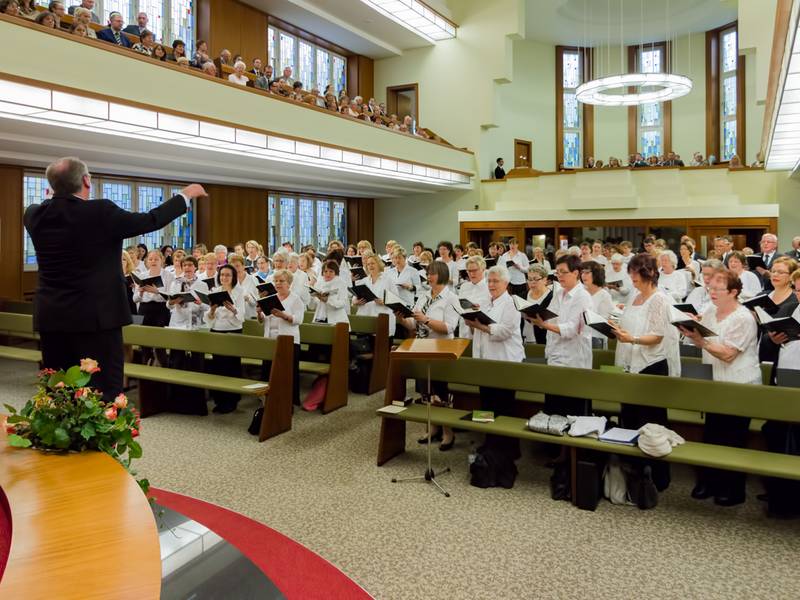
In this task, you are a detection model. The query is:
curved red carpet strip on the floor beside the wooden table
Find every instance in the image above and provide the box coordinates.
[151,488,371,600]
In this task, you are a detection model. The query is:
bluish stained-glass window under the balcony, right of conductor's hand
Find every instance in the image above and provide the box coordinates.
[267,193,347,253]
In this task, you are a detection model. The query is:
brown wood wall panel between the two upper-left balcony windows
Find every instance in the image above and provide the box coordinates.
[196,0,267,66]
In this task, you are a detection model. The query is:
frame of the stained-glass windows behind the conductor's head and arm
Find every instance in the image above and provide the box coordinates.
[22,169,197,272]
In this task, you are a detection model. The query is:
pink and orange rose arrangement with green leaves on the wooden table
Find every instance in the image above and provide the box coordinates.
[5,358,150,493]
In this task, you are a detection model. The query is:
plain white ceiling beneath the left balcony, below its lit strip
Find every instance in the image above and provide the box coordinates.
[0,118,462,198]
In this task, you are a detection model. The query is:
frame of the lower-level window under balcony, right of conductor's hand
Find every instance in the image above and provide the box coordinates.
[266,190,347,256]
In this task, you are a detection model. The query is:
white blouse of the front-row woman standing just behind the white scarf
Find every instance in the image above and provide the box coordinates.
[614,292,677,373]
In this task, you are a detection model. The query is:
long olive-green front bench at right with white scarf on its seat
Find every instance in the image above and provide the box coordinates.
[377,358,800,498]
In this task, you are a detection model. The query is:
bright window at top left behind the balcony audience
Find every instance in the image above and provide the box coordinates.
[65,0,194,56]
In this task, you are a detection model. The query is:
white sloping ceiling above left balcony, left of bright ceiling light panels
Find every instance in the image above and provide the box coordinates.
[243,0,450,59]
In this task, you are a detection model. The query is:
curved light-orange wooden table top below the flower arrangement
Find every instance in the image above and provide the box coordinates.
[0,415,161,600]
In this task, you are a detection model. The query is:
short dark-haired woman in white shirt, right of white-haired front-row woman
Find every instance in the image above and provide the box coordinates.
[532,255,592,416]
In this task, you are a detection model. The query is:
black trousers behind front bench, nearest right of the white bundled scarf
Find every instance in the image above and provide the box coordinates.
[697,413,750,498]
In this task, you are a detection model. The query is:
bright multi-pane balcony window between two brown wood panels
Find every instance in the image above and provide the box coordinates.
[267,27,347,94]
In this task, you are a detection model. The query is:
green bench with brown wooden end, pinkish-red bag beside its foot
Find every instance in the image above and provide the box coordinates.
[242,320,350,414]
